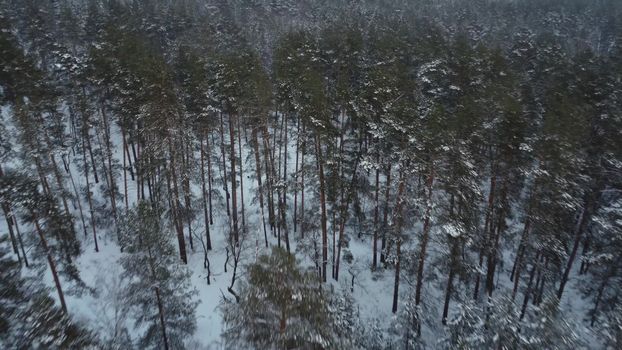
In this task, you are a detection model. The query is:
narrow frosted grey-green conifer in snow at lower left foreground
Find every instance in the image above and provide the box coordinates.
[120,202,197,349]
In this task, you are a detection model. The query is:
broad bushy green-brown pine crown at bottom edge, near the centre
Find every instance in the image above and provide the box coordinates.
[222,247,338,349]
